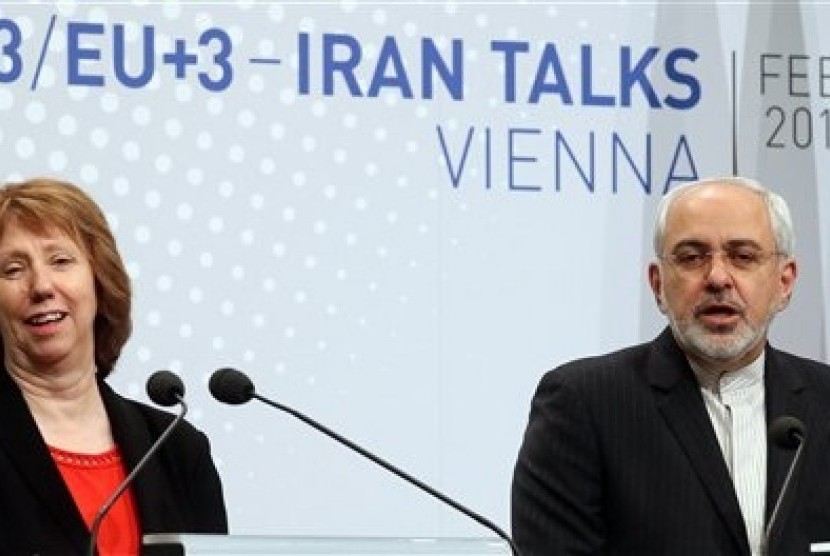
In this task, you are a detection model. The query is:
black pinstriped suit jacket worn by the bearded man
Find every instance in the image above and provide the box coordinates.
[512,329,830,556]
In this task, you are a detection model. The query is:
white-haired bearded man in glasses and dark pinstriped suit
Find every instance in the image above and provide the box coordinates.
[512,178,830,556]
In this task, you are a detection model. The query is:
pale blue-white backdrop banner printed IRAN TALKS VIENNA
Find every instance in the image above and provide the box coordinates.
[0,1,830,536]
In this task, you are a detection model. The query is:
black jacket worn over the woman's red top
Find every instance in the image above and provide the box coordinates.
[0,366,228,555]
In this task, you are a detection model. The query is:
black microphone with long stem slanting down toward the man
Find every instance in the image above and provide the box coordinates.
[208,368,519,556]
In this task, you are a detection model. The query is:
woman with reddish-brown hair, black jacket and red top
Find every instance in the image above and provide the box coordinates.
[0,179,227,555]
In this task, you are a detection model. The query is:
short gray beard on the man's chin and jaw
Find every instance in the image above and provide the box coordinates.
[669,315,772,361]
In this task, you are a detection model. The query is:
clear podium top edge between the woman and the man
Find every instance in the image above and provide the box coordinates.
[144,533,512,556]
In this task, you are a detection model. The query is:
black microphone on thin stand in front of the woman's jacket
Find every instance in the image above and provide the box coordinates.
[87,371,187,556]
